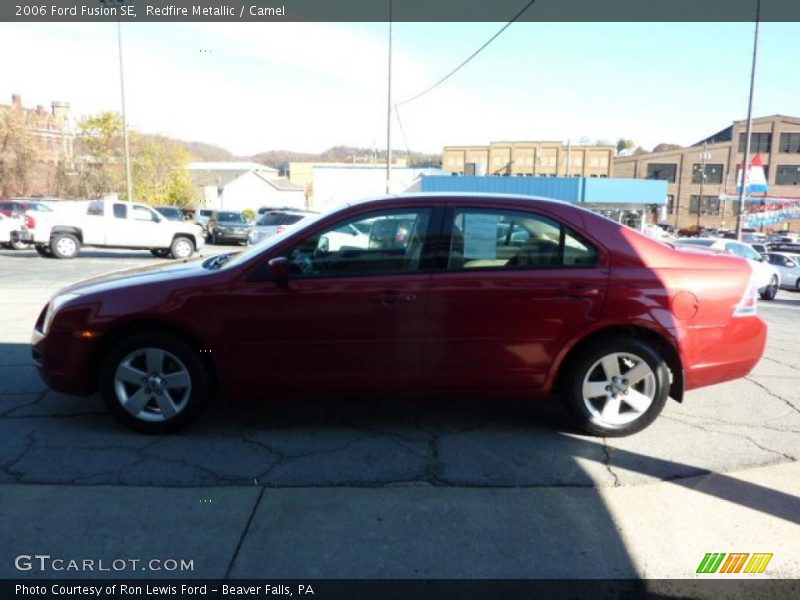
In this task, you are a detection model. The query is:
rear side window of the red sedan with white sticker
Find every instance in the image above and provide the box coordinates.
[447,209,597,270]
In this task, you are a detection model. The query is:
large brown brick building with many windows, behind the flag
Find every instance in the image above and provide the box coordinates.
[614,115,800,229]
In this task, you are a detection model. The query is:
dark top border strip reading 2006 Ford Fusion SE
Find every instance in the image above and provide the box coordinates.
[0,0,800,22]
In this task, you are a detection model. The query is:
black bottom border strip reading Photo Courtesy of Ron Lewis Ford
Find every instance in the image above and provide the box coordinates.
[0,575,800,600]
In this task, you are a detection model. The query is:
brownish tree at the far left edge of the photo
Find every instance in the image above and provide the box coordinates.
[0,108,40,196]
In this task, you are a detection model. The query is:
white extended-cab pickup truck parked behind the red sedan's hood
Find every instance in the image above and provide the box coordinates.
[25,200,205,258]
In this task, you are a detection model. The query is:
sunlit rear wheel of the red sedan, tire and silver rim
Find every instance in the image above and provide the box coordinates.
[561,338,669,437]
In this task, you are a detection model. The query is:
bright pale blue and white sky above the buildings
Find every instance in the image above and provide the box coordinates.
[0,23,800,155]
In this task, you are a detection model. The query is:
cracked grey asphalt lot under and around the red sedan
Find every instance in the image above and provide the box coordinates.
[0,246,800,577]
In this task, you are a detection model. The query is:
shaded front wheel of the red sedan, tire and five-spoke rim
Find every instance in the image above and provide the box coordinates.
[100,333,209,433]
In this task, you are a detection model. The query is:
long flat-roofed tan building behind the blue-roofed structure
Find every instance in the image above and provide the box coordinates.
[442,141,615,177]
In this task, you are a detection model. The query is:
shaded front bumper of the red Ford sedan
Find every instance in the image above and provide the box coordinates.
[31,330,96,396]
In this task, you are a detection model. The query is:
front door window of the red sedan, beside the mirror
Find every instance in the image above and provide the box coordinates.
[287,208,431,277]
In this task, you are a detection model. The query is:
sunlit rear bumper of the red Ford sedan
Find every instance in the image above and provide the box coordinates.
[681,316,767,390]
